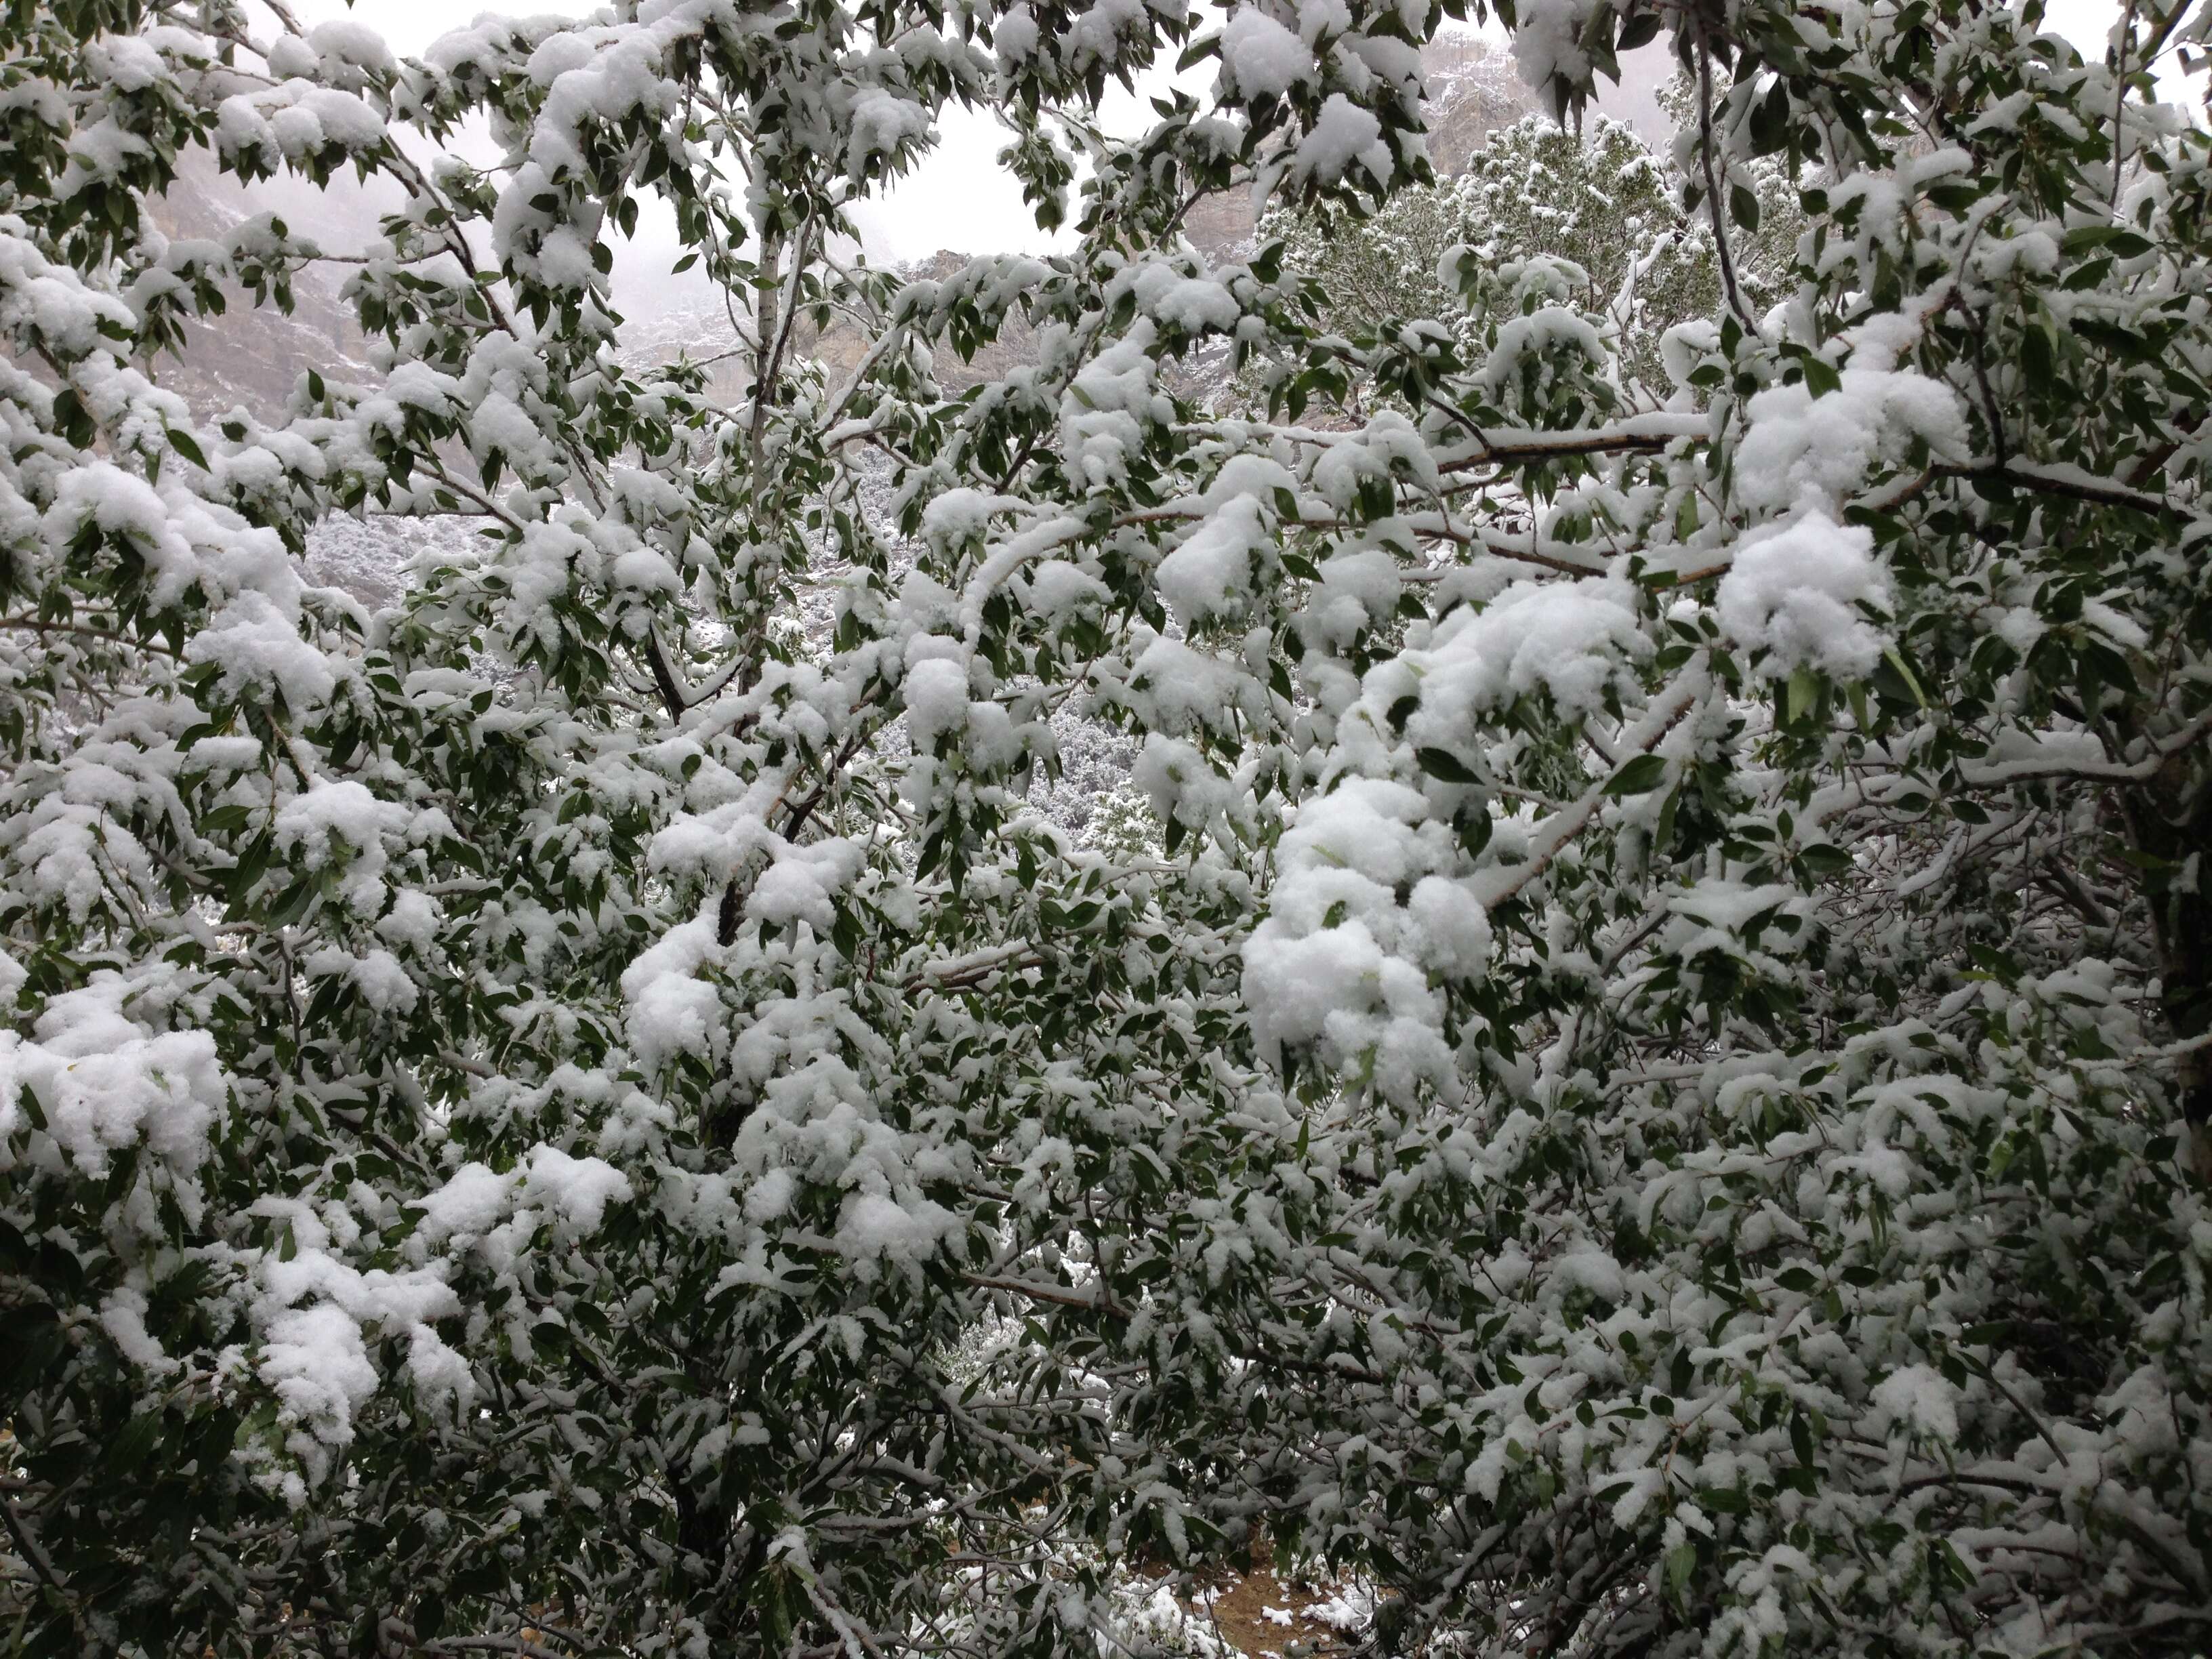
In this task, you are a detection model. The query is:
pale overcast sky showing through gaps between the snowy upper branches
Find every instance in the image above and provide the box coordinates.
[296,0,2184,276]
